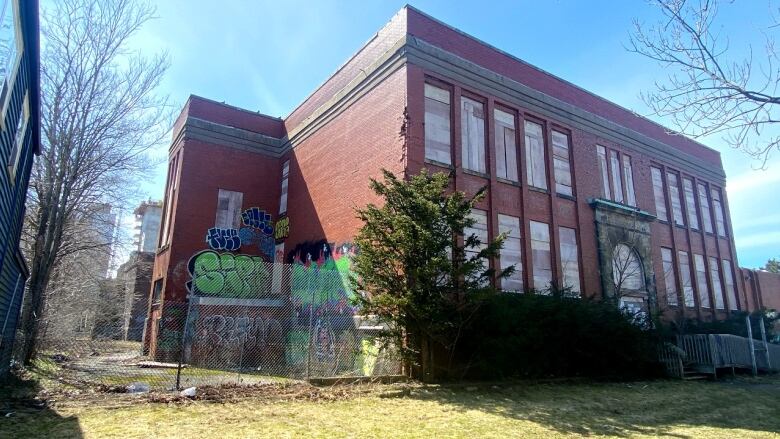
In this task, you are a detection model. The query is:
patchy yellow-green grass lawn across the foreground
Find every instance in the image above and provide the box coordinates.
[0,376,780,438]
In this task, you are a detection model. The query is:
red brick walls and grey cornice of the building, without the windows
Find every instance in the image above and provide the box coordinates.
[147,6,774,358]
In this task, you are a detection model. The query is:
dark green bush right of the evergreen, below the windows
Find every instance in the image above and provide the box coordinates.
[461,294,661,379]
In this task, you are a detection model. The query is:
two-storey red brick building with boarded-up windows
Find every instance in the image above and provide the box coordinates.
[150,6,780,358]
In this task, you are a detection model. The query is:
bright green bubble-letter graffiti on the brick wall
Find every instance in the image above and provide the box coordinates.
[187,250,271,298]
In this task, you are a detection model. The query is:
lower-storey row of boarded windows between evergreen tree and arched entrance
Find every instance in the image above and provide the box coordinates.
[463,209,580,292]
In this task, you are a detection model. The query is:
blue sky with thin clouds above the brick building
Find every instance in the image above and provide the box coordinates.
[119,0,780,267]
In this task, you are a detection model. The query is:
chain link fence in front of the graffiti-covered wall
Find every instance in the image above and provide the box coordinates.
[21,258,401,389]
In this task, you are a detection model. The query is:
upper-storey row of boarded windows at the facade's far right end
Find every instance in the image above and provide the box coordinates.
[650,167,726,237]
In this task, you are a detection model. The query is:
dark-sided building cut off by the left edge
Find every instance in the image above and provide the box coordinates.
[0,0,40,375]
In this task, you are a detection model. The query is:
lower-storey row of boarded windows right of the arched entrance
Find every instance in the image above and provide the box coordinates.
[661,247,739,310]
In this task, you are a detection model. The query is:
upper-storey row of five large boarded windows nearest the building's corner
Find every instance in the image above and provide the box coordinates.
[425,83,574,196]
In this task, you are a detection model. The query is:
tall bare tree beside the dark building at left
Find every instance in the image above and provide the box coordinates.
[22,0,170,363]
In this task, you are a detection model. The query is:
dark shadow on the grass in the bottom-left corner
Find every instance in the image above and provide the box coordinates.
[0,374,83,438]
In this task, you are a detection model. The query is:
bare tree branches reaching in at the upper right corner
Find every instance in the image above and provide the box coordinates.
[629,0,780,165]
